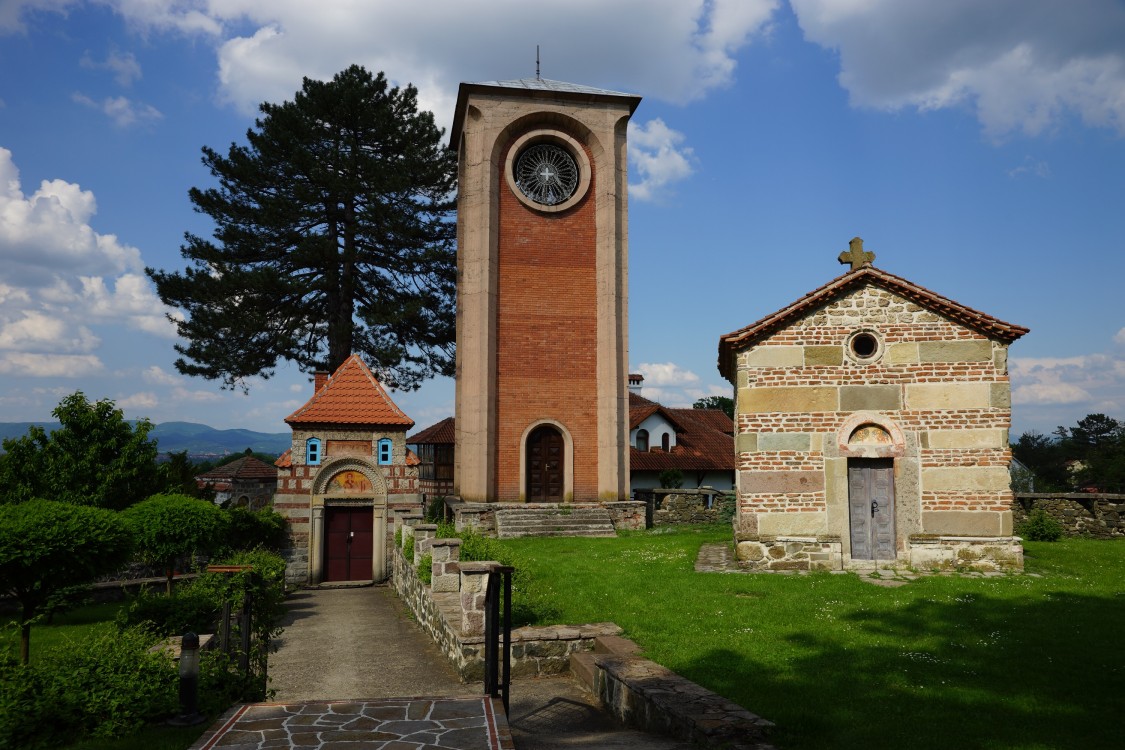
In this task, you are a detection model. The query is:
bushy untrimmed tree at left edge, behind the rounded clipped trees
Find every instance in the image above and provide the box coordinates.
[0,391,160,509]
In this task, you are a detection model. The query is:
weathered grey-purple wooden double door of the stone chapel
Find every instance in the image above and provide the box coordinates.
[847,459,894,560]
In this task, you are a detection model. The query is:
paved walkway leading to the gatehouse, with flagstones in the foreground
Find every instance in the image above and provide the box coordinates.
[191,586,694,750]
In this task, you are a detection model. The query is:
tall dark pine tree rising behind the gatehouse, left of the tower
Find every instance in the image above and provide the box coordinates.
[147,65,456,389]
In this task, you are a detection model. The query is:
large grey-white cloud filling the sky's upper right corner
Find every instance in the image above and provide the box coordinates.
[790,0,1125,138]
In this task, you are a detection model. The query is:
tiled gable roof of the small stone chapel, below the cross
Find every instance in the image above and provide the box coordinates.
[719,265,1028,381]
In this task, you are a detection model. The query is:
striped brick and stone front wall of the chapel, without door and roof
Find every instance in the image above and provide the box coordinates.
[735,284,1026,566]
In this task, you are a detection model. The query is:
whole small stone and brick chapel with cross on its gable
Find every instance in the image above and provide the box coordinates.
[719,244,1027,570]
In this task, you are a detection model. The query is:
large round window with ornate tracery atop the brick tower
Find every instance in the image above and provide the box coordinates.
[504,129,591,214]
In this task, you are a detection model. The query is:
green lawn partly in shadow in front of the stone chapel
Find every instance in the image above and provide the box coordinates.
[505,527,1125,750]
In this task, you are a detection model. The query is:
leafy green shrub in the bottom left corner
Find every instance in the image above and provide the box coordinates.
[0,627,179,748]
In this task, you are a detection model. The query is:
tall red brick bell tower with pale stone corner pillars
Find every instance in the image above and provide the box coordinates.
[450,78,640,503]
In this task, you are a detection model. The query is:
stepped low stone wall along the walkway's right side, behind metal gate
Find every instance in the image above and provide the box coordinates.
[393,517,621,683]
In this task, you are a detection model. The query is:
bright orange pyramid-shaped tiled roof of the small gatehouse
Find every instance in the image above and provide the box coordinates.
[285,354,414,428]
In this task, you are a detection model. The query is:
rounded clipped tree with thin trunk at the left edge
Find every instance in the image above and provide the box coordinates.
[0,499,133,663]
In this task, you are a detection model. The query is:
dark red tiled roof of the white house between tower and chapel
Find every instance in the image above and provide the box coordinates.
[629,394,735,471]
